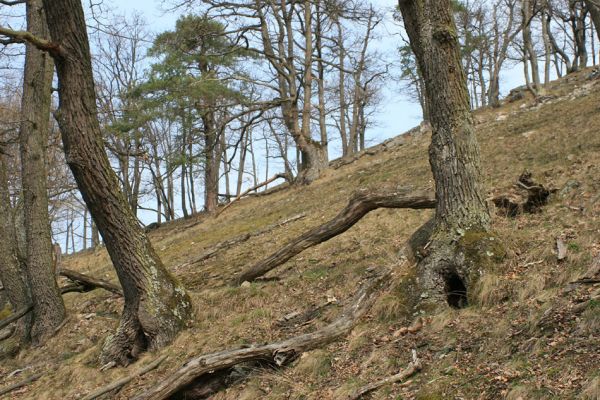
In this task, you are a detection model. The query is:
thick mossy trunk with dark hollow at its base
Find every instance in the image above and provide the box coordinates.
[399,0,497,306]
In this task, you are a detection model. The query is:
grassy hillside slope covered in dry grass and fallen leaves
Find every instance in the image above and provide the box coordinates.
[0,69,600,400]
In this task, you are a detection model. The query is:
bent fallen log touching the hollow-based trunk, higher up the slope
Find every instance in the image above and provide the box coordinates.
[235,189,435,285]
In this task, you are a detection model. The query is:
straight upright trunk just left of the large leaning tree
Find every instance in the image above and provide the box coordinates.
[19,0,66,345]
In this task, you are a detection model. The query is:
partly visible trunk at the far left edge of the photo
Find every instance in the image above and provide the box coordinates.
[0,152,30,342]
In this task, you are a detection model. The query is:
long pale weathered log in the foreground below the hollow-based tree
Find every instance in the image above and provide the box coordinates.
[135,269,391,400]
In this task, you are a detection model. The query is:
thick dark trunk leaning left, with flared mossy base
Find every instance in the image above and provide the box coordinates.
[44,0,192,364]
